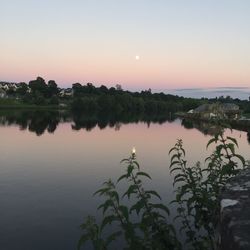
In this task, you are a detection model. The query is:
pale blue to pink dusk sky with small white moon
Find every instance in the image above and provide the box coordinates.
[0,0,250,90]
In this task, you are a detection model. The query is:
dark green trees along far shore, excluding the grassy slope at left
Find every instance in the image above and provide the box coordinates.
[1,77,250,118]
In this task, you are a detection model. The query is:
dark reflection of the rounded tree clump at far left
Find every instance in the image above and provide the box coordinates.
[1,110,60,136]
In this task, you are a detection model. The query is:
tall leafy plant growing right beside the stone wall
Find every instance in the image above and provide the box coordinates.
[169,132,246,249]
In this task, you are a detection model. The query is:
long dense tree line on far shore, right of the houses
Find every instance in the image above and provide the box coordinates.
[71,83,202,115]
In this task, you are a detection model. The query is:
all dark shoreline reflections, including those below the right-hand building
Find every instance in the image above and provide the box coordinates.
[0,110,250,144]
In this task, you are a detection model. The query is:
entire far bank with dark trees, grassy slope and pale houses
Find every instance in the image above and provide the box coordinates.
[0,77,250,115]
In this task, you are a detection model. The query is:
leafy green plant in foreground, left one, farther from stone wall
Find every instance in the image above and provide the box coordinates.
[79,153,180,250]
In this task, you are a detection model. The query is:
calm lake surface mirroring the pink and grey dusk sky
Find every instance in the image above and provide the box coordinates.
[0,114,250,250]
